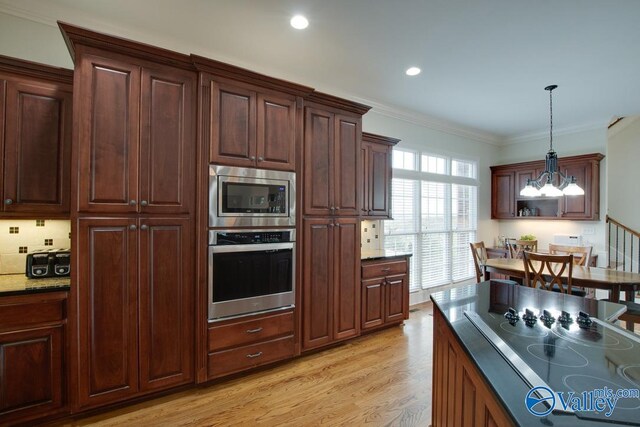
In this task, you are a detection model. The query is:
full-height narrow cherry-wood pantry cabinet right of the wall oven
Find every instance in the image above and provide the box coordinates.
[302,92,369,350]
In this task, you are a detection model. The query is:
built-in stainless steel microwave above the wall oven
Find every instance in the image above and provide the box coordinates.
[209,165,296,227]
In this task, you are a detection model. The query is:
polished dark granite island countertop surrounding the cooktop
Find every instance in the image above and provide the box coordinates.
[431,282,624,427]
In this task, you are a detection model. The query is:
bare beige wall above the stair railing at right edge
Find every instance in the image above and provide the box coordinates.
[607,116,640,231]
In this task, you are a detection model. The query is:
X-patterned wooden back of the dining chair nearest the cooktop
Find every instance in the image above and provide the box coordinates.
[522,251,573,294]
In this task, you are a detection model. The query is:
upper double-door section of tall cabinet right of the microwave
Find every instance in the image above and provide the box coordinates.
[303,93,369,216]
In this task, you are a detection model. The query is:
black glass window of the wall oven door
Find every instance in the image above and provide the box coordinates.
[212,249,293,303]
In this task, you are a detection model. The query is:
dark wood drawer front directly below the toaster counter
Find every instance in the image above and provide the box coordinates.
[0,294,67,329]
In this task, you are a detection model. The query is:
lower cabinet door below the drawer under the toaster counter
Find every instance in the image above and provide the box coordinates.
[0,326,65,425]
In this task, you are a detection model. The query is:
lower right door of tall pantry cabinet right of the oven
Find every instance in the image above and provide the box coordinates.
[333,218,360,340]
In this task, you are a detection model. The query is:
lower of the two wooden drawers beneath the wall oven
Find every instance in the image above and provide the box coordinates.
[208,336,295,378]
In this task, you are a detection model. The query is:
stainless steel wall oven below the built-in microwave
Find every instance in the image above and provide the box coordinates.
[209,230,295,321]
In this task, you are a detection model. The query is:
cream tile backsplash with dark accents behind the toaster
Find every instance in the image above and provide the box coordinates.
[0,219,71,274]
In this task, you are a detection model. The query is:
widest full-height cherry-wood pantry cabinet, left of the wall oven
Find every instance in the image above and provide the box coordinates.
[60,24,197,410]
